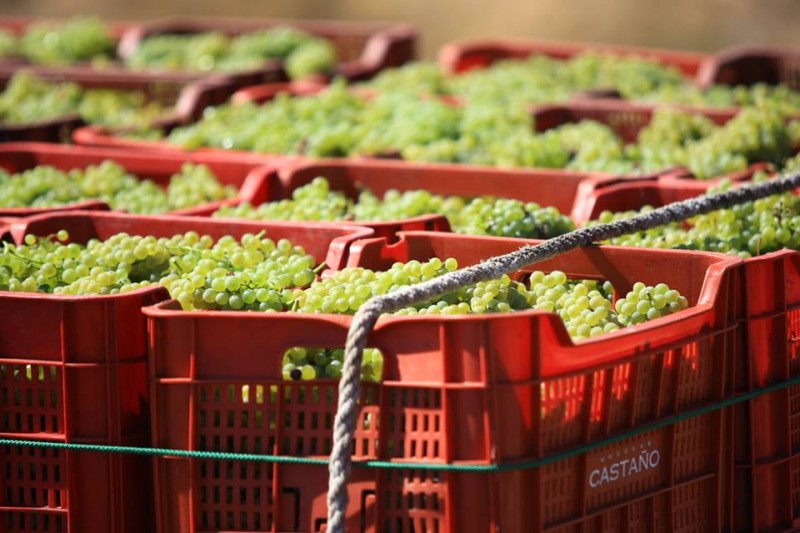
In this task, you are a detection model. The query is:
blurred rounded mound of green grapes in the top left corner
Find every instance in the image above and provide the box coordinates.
[17,17,116,65]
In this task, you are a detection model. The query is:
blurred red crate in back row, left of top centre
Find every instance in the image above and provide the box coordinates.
[118,18,417,86]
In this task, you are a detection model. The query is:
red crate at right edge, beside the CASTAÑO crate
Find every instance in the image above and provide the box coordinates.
[560,175,800,531]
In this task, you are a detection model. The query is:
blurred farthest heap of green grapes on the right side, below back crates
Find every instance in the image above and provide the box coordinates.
[363,56,800,115]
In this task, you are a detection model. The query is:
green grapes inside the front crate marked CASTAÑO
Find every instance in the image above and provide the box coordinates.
[283,258,689,381]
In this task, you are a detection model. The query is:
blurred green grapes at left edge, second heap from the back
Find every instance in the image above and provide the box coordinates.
[0,72,164,127]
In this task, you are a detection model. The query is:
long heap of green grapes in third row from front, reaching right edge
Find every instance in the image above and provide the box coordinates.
[155,83,800,179]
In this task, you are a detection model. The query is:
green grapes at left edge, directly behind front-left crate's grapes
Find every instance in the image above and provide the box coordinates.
[0,160,236,214]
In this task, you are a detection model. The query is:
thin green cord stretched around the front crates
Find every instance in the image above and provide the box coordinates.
[0,376,800,472]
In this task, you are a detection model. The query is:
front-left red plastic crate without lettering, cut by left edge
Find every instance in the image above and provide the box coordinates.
[0,212,370,533]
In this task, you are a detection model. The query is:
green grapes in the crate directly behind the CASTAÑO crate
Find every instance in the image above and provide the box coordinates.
[214,177,575,238]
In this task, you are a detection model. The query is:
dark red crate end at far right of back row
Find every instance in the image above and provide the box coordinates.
[698,46,800,90]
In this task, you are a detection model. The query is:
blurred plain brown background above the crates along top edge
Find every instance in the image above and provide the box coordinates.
[2,0,800,58]
